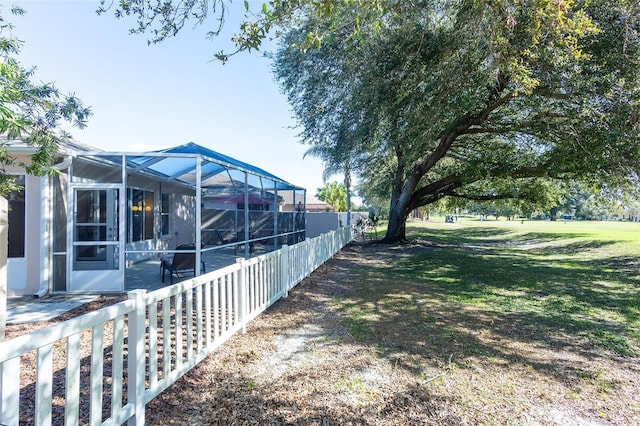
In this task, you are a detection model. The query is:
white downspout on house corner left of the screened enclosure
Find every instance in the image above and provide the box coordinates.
[33,155,73,298]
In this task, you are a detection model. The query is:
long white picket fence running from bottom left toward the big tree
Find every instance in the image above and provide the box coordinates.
[0,228,353,426]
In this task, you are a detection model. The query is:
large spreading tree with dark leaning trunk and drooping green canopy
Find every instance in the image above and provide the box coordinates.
[275,0,640,241]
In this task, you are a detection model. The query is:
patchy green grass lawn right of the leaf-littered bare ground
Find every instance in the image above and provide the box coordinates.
[336,217,640,424]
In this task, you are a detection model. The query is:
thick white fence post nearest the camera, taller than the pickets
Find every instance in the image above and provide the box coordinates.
[127,289,147,426]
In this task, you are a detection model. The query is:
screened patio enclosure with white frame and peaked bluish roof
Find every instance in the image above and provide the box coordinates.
[52,143,306,292]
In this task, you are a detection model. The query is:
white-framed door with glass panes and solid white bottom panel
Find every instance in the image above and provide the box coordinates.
[69,187,124,292]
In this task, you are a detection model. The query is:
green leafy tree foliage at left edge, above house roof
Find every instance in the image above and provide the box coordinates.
[0,7,91,195]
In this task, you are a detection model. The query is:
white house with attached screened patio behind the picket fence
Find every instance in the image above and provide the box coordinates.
[3,140,306,296]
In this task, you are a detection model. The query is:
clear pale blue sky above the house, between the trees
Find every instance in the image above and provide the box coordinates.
[12,0,332,196]
